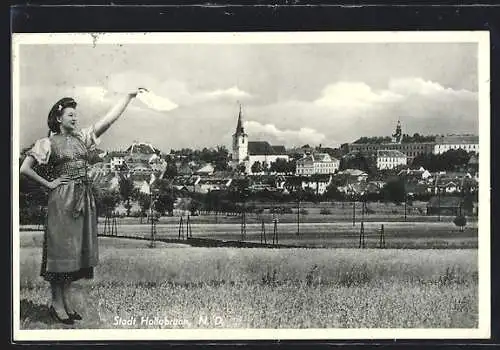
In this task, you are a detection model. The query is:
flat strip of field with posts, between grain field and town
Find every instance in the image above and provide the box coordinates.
[95,216,478,249]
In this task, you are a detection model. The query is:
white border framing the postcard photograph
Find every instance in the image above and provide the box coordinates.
[11,31,491,341]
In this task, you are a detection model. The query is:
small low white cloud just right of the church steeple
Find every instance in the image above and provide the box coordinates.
[245,121,325,146]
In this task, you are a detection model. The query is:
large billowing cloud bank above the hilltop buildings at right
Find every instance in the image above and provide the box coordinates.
[248,77,478,146]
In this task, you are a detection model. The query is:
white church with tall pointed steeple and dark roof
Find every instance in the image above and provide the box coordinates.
[232,106,289,174]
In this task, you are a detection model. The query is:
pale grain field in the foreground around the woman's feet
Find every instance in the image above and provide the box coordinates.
[20,232,478,329]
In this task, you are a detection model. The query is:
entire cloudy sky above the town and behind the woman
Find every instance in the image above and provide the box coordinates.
[15,43,478,152]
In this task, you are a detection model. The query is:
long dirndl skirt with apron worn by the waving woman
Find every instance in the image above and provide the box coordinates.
[40,180,98,281]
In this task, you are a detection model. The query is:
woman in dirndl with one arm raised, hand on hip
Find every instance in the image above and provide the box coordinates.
[20,91,138,324]
